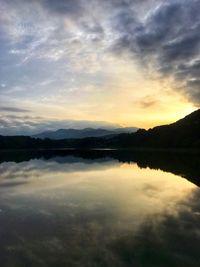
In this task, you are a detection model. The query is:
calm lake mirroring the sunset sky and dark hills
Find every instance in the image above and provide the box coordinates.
[0,150,200,267]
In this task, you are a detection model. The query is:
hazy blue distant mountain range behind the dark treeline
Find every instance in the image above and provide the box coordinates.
[32,128,137,140]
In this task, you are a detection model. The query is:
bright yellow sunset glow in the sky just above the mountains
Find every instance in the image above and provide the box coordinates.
[6,57,197,129]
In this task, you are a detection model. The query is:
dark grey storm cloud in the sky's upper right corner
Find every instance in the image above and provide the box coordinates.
[113,0,200,104]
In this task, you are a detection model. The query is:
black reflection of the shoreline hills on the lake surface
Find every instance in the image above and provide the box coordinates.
[0,150,200,185]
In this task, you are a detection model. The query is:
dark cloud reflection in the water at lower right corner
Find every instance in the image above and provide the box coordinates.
[111,189,200,267]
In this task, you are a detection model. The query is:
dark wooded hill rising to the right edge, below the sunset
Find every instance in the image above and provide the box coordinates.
[60,109,200,149]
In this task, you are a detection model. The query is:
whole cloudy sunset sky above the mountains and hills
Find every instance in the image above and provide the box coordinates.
[0,0,200,135]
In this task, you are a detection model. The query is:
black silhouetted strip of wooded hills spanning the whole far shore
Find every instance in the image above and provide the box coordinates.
[0,110,200,150]
